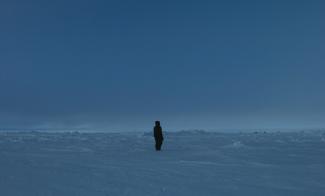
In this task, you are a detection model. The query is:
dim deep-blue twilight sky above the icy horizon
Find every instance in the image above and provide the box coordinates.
[0,0,325,131]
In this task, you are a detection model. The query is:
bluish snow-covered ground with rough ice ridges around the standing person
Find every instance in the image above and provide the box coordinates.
[0,131,325,196]
